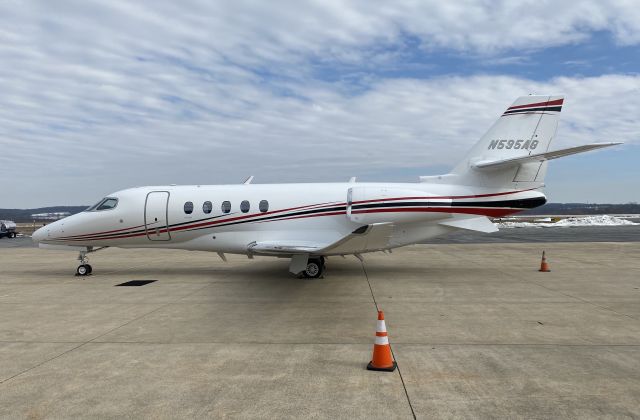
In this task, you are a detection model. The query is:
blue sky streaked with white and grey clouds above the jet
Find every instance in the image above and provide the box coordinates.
[0,0,640,208]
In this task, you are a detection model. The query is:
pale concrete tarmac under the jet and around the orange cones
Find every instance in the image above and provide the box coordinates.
[0,238,640,419]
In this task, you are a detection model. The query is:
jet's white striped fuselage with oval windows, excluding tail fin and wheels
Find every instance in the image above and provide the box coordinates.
[34,183,545,255]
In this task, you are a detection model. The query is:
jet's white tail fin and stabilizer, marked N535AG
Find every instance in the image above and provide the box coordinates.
[421,95,621,190]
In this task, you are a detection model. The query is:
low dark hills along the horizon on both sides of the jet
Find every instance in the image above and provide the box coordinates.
[0,203,640,223]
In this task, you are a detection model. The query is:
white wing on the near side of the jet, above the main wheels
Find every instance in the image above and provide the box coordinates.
[247,223,393,255]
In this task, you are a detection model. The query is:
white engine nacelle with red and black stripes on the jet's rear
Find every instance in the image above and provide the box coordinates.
[347,186,451,224]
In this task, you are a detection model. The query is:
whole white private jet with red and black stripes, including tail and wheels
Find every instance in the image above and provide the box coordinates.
[33,96,620,277]
